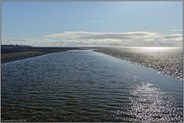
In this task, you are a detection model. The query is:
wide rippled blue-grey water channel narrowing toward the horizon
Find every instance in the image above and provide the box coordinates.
[1,50,183,122]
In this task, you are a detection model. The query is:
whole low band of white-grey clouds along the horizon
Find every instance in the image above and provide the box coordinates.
[2,31,183,47]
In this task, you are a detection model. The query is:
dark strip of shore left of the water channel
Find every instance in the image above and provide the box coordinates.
[1,45,81,63]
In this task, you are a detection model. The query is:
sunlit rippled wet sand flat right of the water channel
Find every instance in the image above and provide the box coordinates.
[96,47,183,79]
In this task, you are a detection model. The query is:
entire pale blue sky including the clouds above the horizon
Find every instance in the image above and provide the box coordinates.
[2,1,183,47]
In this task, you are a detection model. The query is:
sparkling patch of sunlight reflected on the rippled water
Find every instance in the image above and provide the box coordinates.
[130,82,183,122]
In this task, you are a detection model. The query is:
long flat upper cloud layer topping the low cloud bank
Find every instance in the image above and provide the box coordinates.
[45,31,160,40]
